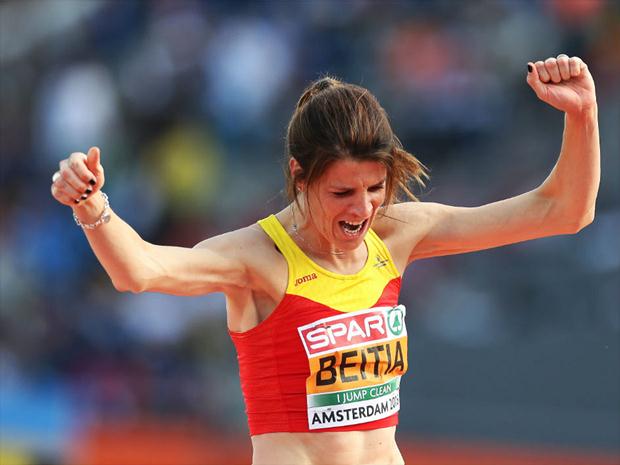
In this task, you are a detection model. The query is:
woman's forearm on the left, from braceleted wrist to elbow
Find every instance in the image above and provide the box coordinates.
[73,194,148,291]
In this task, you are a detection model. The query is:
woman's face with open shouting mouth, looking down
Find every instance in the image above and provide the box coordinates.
[306,159,387,250]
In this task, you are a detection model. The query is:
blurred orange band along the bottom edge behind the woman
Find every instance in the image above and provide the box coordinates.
[67,421,620,465]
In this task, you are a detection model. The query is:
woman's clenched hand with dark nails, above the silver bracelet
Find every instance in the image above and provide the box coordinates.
[51,147,105,207]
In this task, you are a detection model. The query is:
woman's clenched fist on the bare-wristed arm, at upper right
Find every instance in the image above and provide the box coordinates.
[527,54,596,113]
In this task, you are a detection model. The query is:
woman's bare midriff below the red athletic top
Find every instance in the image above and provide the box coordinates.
[252,426,405,465]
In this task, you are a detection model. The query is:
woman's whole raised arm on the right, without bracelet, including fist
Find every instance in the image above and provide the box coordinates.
[386,55,600,262]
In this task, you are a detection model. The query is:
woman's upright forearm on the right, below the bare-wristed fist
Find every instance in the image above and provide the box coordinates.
[538,105,600,232]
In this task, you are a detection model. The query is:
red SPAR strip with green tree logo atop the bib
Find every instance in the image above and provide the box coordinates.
[298,305,406,357]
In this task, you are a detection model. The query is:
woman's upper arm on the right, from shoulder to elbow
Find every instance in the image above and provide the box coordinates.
[380,186,573,263]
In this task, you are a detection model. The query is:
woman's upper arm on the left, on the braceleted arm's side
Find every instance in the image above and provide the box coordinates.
[135,228,251,295]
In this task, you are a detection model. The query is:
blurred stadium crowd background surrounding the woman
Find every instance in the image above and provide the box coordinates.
[0,0,620,465]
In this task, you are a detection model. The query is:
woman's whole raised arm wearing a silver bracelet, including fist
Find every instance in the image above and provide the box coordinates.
[52,147,247,295]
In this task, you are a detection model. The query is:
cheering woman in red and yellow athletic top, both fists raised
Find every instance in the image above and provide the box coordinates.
[52,55,599,465]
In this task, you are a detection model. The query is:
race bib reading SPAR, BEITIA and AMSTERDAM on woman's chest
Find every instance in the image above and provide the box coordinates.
[298,305,407,430]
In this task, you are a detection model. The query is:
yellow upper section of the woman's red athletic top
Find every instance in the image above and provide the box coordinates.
[258,215,400,312]
